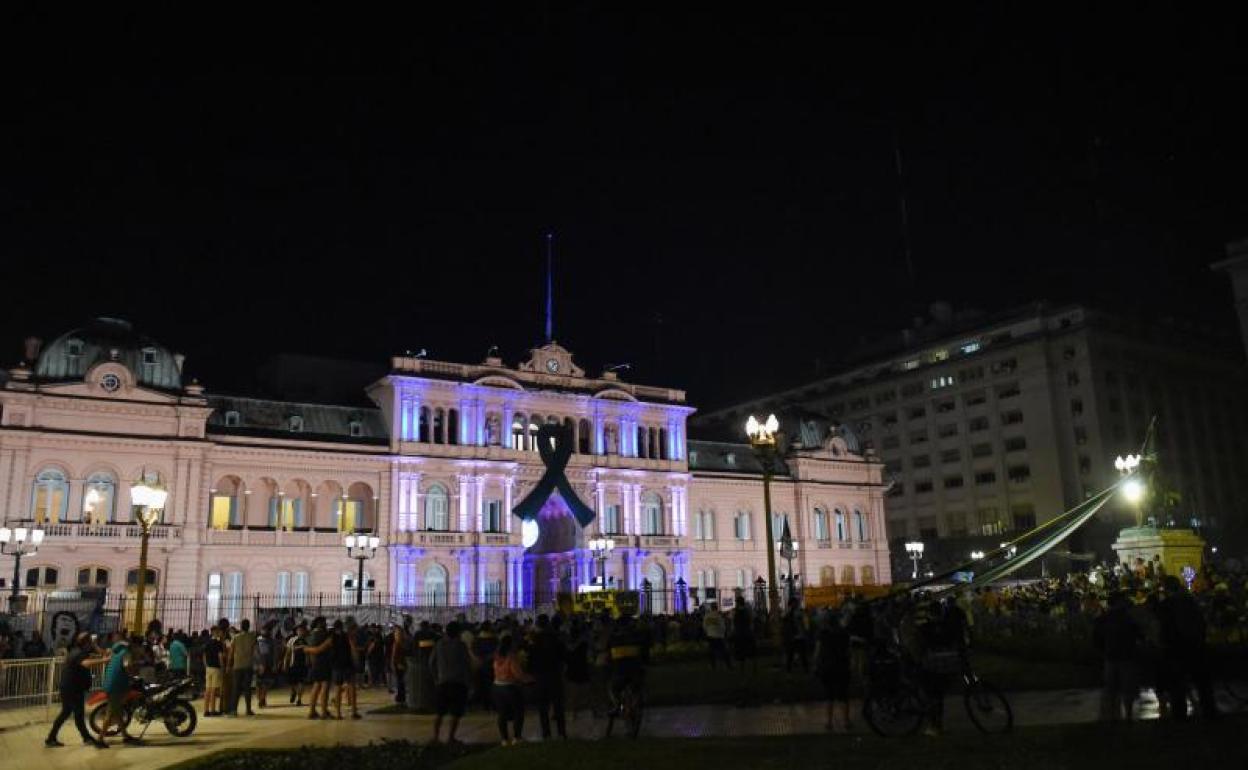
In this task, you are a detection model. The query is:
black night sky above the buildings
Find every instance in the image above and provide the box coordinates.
[0,2,1248,407]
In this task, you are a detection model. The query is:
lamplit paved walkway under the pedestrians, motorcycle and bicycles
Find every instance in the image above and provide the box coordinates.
[0,690,1232,770]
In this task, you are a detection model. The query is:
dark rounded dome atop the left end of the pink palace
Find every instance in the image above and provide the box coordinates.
[35,318,182,391]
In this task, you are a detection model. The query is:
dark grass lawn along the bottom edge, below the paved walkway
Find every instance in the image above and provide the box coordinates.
[439,719,1248,770]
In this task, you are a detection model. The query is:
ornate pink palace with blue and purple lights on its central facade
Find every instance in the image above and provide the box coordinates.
[0,318,890,616]
